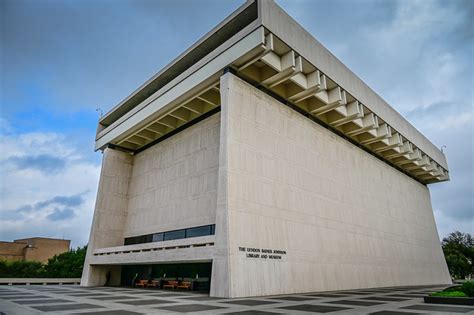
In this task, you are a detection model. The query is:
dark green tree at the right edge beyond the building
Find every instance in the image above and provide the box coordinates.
[442,231,474,279]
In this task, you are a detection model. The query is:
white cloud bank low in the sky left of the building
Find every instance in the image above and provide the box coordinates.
[0,132,100,246]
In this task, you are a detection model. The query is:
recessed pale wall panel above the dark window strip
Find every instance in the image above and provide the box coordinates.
[124,114,220,237]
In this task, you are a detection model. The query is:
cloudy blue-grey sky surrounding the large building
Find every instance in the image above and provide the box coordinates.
[0,0,474,246]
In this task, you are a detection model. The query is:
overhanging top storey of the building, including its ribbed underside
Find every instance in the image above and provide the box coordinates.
[96,0,449,184]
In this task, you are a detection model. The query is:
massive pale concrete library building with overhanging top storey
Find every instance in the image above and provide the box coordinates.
[81,0,451,297]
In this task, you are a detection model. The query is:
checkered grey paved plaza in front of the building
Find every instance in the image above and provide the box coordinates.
[0,285,474,315]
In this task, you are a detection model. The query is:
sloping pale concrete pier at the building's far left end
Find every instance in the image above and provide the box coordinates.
[81,148,134,286]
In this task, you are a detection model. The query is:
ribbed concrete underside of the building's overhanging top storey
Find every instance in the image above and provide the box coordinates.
[111,32,449,183]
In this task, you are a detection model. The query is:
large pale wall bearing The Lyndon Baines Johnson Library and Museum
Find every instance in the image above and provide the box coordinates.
[211,74,450,297]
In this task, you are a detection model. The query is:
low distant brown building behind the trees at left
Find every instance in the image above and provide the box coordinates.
[0,237,71,262]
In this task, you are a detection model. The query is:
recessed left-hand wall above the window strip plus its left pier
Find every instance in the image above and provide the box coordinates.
[81,114,220,286]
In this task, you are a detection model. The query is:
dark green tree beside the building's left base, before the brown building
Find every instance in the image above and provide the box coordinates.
[44,246,87,278]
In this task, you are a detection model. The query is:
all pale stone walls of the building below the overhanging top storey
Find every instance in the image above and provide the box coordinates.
[82,73,450,297]
